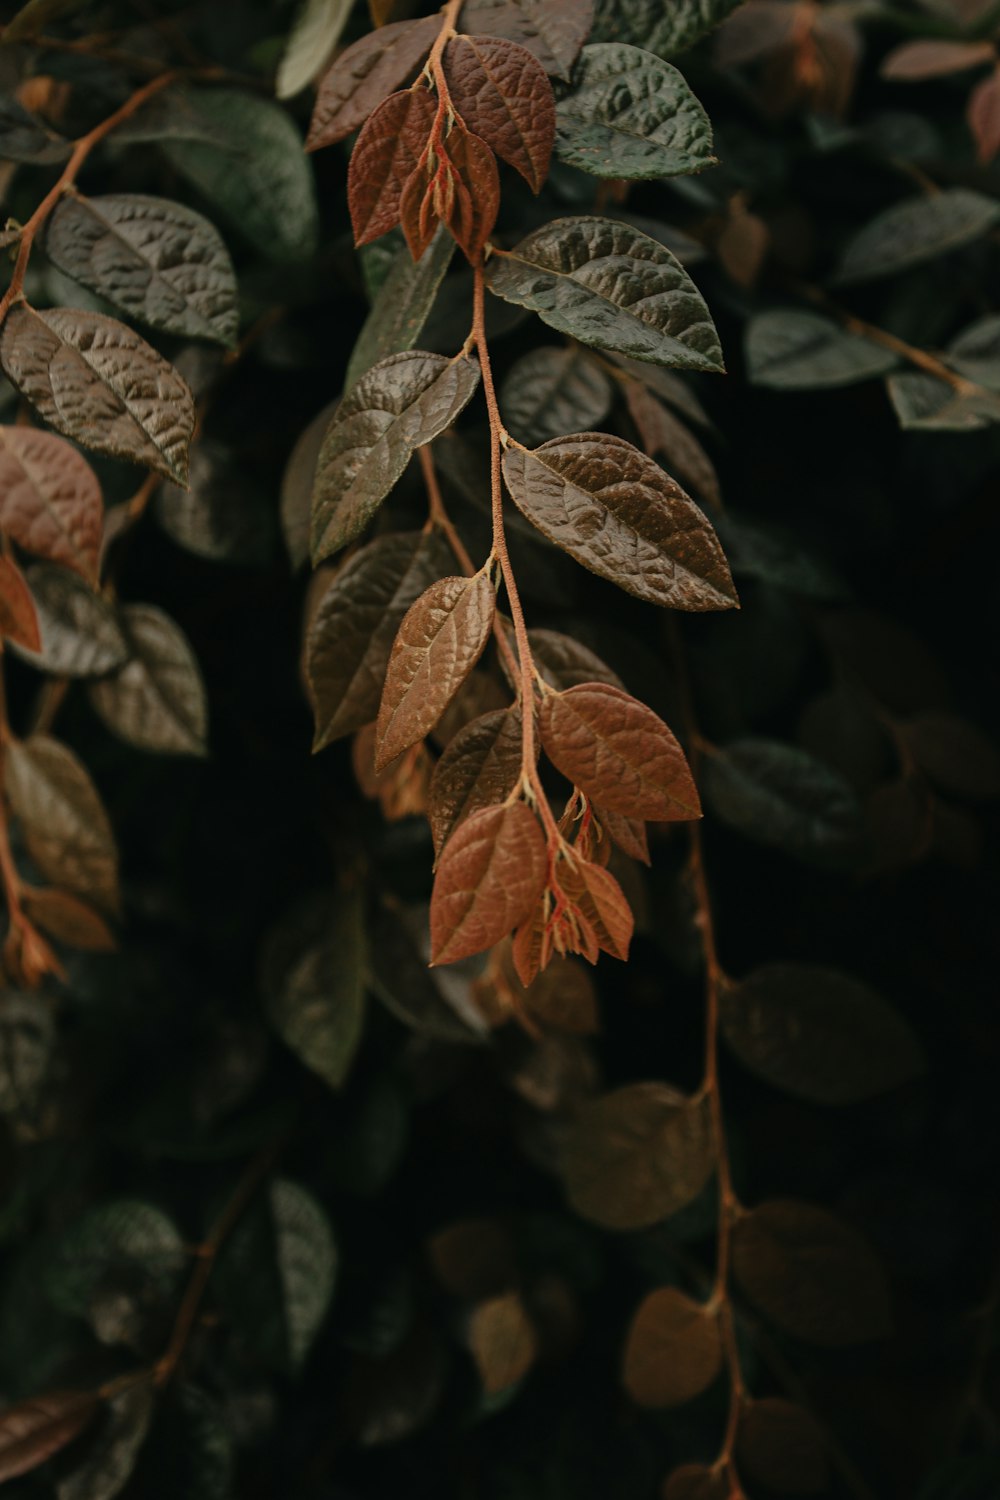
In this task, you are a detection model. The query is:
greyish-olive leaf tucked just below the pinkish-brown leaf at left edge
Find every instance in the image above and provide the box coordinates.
[7,563,129,677]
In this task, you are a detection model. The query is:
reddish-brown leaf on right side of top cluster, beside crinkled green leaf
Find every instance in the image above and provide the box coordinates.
[444,36,556,192]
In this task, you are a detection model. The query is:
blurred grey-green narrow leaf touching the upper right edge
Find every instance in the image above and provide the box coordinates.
[837,188,1000,285]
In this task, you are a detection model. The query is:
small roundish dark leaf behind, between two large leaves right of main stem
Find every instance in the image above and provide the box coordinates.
[501,348,612,446]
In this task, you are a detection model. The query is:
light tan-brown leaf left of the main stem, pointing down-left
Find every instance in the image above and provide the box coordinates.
[375,573,496,771]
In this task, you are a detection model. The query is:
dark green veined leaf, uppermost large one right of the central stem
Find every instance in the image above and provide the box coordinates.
[489,218,724,372]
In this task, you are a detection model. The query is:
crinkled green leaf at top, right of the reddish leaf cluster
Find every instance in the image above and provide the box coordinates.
[556,44,715,180]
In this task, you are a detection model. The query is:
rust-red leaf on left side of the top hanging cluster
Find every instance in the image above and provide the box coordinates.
[348,89,435,245]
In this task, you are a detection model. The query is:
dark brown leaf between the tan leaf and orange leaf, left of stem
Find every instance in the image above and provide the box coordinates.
[429,707,522,855]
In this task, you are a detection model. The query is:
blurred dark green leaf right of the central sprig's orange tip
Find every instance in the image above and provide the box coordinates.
[705,740,858,866]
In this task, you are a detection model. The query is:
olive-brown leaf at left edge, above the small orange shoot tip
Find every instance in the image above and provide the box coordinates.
[4,735,118,912]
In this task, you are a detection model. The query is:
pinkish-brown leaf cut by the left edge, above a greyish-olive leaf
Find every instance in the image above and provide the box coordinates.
[0,428,103,584]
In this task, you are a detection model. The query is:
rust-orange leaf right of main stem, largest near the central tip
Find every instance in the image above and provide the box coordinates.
[538,683,702,821]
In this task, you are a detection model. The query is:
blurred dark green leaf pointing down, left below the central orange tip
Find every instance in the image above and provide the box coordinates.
[267,891,366,1089]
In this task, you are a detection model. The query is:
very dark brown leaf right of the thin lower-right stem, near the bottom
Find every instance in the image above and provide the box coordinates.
[733,1199,891,1349]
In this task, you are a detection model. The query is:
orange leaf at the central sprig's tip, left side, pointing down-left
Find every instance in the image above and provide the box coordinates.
[430,803,549,963]
